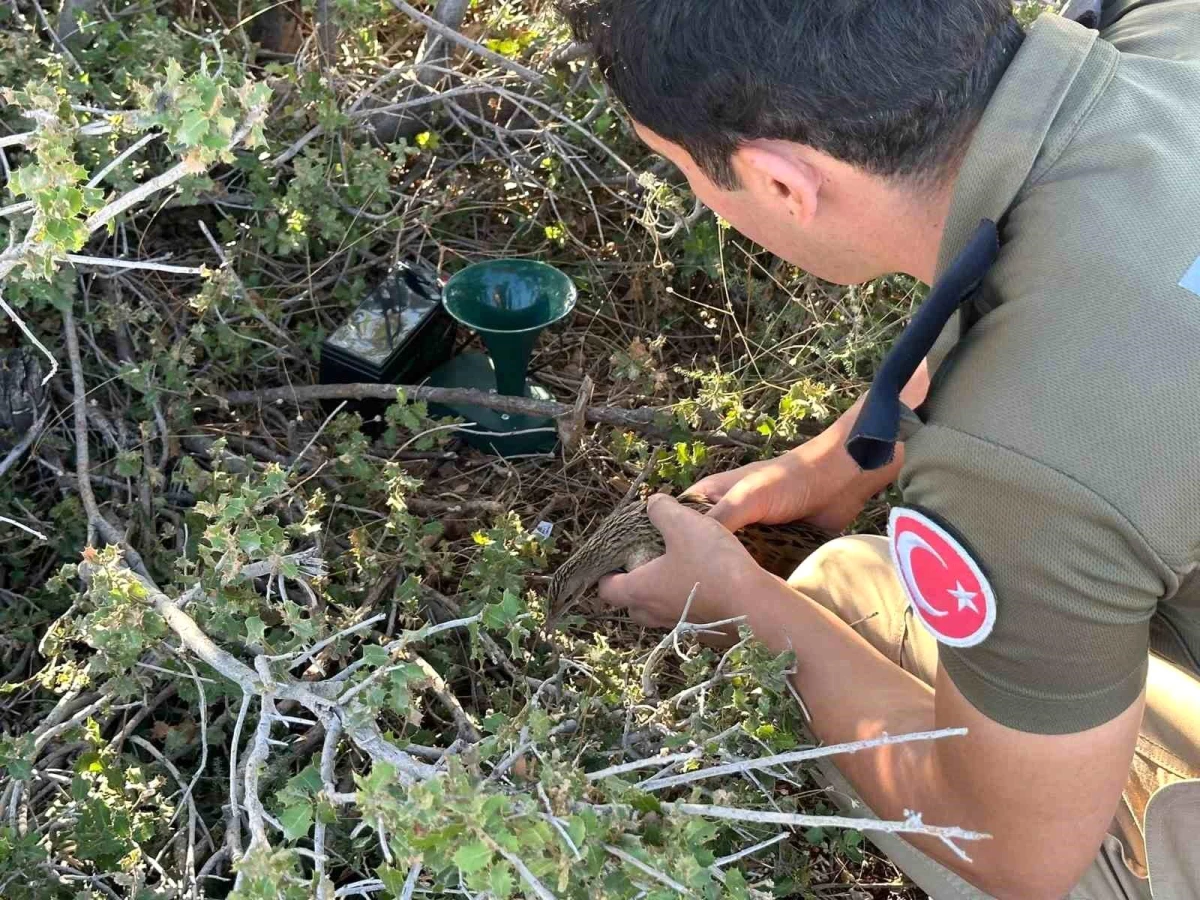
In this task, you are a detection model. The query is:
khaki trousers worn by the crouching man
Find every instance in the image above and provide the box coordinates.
[788,535,1200,900]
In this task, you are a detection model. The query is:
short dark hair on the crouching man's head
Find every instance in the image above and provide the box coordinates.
[559,0,1024,188]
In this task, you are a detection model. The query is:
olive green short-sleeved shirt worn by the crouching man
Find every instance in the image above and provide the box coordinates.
[900,0,1200,733]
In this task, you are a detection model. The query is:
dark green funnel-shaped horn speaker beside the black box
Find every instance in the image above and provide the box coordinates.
[428,259,577,456]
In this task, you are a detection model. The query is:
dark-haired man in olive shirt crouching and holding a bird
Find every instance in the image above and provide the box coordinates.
[564,0,1200,900]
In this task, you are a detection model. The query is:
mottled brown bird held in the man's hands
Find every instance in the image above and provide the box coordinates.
[542,493,836,634]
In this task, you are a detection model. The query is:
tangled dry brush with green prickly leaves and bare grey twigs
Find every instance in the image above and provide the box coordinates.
[0,0,998,900]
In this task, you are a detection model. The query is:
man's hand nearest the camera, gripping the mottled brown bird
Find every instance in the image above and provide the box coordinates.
[598,494,770,635]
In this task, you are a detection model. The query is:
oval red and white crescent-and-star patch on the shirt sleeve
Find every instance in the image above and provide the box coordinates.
[888,506,996,647]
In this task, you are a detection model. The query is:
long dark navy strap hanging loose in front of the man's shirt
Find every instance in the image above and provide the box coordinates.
[846,218,1000,469]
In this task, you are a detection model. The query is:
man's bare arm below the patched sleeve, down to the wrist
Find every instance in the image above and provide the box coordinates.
[744,576,1142,900]
